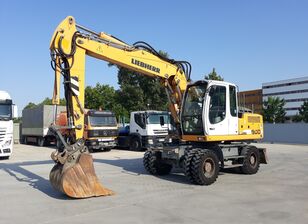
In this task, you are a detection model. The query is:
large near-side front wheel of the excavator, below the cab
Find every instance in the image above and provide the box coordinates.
[191,149,219,185]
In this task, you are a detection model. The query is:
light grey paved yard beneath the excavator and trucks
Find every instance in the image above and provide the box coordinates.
[0,144,308,224]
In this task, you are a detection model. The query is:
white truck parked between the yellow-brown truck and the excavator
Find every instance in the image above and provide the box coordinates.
[118,110,172,151]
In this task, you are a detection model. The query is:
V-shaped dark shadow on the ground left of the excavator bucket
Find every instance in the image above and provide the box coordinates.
[0,160,70,200]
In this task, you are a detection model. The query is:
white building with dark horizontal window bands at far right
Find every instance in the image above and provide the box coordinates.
[262,76,308,117]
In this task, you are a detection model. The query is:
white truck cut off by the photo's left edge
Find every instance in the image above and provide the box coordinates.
[0,91,18,159]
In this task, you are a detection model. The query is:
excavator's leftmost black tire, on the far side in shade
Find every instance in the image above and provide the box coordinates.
[143,151,172,175]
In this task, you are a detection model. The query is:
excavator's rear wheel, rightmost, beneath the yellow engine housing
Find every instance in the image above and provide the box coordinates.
[240,146,260,174]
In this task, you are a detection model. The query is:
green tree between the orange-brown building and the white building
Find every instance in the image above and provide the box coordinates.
[263,97,286,123]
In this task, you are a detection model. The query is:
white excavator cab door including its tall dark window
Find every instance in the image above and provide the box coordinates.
[205,84,229,135]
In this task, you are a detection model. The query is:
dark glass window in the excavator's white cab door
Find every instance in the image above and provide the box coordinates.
[209,85,226,124]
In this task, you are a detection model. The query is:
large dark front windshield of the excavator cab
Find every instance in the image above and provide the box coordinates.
[182,83,207,135]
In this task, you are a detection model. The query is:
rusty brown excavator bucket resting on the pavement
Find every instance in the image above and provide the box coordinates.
[49,153,114,198]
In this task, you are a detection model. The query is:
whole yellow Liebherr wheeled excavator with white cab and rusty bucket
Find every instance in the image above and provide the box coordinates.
[50,16,267,198]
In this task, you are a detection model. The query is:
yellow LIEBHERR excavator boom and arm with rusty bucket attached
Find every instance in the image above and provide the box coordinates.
[50,16,191,198]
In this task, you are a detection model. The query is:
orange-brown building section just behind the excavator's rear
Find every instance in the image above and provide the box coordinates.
[238,89,262,114]
